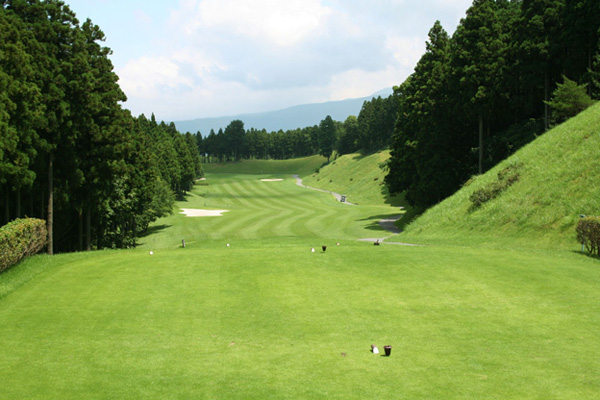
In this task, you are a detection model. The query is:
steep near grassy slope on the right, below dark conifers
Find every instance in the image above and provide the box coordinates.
[401,104,600,250]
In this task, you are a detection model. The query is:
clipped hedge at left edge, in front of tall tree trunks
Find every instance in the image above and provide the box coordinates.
[0,218,48,272]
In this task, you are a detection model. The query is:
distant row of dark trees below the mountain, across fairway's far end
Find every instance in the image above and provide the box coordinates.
[196,95,398,162]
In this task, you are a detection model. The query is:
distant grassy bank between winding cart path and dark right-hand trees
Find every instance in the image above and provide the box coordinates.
[304,151,406,206]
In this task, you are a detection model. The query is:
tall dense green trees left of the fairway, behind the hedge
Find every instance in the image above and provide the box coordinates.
[0,0,202,253]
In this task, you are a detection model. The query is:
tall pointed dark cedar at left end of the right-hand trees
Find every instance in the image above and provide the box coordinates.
[386,21,461,206]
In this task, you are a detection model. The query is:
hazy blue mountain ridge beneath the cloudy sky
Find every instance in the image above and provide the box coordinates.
[174,88,393,136]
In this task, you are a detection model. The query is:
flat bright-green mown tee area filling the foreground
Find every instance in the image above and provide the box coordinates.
[0,242,600,400]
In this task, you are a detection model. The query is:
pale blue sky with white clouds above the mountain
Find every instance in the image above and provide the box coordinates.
[65,0,472,121]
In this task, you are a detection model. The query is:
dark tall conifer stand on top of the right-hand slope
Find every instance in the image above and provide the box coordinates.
[386,0,600,208]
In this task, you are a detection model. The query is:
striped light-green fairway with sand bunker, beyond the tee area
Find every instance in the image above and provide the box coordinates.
[140,172,398,248]
